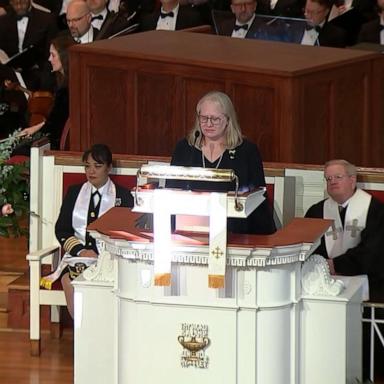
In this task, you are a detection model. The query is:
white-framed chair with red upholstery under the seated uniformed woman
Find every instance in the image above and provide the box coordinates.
[26,144,138,356]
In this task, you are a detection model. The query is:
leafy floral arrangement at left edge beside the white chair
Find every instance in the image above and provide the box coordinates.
[0,130,29,237]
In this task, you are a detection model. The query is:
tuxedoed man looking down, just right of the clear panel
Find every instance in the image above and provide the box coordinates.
[301,0,347,48]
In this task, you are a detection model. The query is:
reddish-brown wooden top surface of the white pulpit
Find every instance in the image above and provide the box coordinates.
[88,207,332,248]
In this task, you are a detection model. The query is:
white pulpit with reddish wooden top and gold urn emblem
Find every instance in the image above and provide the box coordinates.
[74,166,362,384]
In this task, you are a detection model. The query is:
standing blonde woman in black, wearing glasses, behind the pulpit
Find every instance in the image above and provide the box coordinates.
[167,91,276,234]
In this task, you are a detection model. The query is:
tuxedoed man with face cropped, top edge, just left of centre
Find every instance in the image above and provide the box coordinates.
[140,0,204,31]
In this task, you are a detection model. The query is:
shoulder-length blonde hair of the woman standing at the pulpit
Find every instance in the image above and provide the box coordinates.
[187,91,243,149]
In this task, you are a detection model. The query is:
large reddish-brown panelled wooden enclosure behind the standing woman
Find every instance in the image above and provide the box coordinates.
[70,31,382,165]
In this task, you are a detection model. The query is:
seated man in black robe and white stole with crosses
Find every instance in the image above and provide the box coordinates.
[306,160,384,302]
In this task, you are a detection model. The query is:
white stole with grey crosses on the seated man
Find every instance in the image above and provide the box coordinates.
[323,189,372,258]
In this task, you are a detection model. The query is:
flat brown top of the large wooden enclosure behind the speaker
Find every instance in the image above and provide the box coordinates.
[71,31,379,77]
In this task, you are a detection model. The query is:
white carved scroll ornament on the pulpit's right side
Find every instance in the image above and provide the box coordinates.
[301,255,344,296]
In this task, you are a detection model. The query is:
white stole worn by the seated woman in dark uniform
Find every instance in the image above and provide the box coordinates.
[72,179,116,244]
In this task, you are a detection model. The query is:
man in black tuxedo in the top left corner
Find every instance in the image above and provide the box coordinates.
[0,0,57,90]
